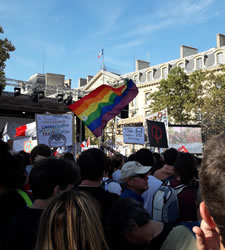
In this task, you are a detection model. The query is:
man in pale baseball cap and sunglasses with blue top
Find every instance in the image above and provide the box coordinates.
[121,161,151,204]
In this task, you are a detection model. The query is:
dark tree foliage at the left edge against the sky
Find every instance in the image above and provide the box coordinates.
[0,26,15,90]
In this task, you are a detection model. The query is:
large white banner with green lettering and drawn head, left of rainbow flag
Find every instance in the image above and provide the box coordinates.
[36,113,74,148]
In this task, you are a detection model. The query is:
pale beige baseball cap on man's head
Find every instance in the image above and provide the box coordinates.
[121,161,152,180]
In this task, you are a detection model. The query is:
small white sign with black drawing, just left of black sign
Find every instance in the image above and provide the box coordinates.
[123,127,145,144]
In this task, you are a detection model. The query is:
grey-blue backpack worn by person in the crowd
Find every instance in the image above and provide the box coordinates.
[152,181,188,223]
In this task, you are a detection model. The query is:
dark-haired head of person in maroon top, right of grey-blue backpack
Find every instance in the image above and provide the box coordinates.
[174,152,197,185]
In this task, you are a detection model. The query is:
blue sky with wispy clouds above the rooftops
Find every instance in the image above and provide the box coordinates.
[0,0,225,88]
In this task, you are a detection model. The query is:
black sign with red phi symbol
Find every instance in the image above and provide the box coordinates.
[147,120,168,148]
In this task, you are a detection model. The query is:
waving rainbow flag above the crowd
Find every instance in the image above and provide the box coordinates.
[68,80,138,137]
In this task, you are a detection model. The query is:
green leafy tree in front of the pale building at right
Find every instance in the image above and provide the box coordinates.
[150,66,225,140]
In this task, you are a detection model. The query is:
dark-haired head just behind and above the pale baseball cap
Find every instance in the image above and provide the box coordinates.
[133,148,155,167]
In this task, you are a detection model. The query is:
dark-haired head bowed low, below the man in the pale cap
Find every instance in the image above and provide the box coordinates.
[109,198,152,245]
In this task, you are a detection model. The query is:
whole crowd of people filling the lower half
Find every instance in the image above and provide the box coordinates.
[0,135,225,250]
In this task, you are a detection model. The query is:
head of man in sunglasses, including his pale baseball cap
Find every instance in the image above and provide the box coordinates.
[121,161,151,194]
